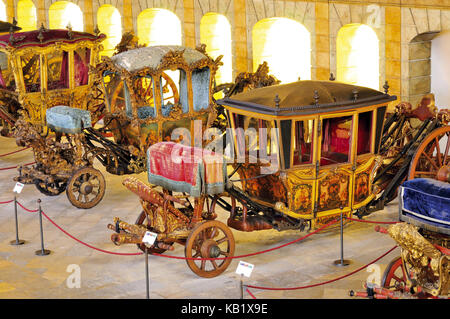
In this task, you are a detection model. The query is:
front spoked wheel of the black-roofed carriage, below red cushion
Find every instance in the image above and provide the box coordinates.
[184,220,235,278]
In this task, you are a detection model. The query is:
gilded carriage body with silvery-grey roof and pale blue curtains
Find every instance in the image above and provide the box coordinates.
[98,46,220,158]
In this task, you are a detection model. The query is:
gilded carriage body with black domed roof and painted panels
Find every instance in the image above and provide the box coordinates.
[218,81,396,226]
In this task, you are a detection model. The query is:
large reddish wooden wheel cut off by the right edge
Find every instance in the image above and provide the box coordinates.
[408,125,450,180]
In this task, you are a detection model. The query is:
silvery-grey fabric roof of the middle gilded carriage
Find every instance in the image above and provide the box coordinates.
[111,45,211,73]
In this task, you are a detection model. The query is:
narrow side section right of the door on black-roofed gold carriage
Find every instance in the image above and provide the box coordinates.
[352,110,376,210]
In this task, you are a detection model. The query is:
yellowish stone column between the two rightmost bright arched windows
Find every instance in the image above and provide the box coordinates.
[311,2,330,80]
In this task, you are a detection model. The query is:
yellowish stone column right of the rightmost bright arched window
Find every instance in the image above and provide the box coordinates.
[380,6,402,109]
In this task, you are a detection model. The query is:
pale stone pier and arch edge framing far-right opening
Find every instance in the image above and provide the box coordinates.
[401,8,450,107]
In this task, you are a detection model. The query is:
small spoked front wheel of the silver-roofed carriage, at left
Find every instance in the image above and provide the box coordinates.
[66,167,106,209]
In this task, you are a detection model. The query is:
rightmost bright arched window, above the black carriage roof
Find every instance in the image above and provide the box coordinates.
[336,23,380,90]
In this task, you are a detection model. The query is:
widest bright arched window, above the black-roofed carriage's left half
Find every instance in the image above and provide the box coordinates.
[252,18,311,83]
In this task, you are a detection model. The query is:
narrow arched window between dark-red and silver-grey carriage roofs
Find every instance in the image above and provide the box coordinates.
[97,4,122,56]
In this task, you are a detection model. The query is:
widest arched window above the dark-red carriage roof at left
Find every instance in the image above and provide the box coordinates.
[48,1,84,31]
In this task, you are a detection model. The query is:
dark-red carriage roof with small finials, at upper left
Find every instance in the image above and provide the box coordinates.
[0,28,106,49]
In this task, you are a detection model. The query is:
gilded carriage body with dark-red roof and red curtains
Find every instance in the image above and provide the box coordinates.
[0,27,105,131]
